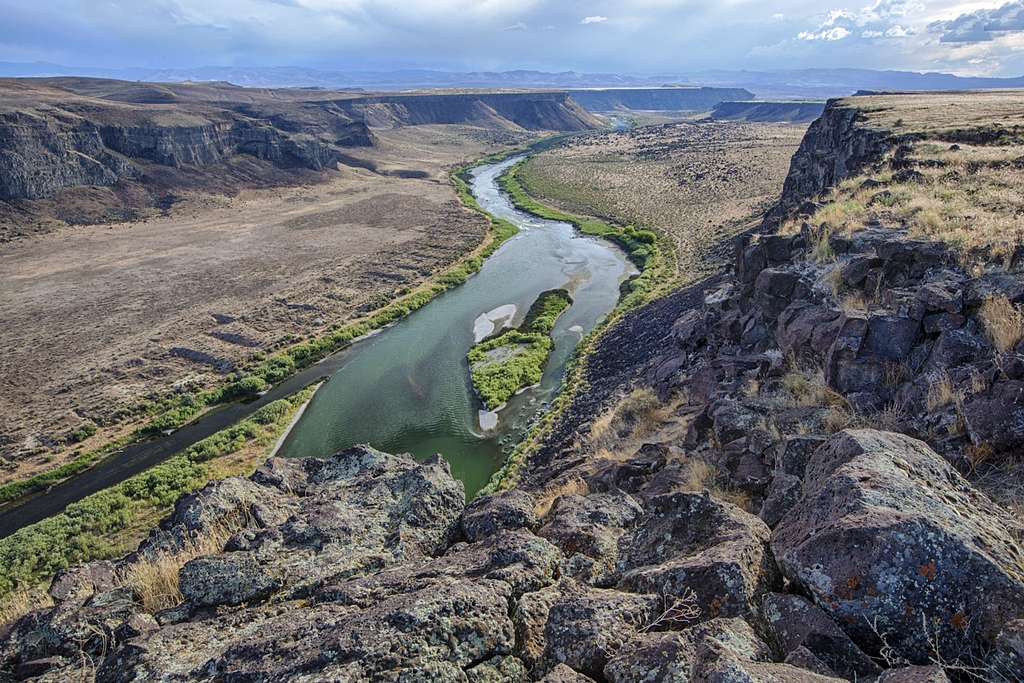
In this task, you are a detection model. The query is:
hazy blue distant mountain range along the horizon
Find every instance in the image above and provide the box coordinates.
[0,62,1024,98]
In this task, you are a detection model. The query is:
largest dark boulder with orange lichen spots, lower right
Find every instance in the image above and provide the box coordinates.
[772,430,1024,661]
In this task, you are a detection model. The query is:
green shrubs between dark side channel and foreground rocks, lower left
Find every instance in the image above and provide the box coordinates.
[0,386,316,599]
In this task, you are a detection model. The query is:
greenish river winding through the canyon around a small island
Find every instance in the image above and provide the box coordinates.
[281,157,636,495]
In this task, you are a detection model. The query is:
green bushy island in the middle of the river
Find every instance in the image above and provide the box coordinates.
[467,290,572,411]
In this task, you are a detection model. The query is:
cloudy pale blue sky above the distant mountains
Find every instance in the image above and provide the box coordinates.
[0,0,1024,76]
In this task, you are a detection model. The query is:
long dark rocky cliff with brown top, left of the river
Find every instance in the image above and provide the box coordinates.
[0,79,600,201]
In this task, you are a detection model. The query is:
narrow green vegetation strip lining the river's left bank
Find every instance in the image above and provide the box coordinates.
[0,148,522,504]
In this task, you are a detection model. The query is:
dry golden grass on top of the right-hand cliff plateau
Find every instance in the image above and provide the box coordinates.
[782,93,1024,268]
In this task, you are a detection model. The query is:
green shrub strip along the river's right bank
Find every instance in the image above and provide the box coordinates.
[477,156,676,496]
